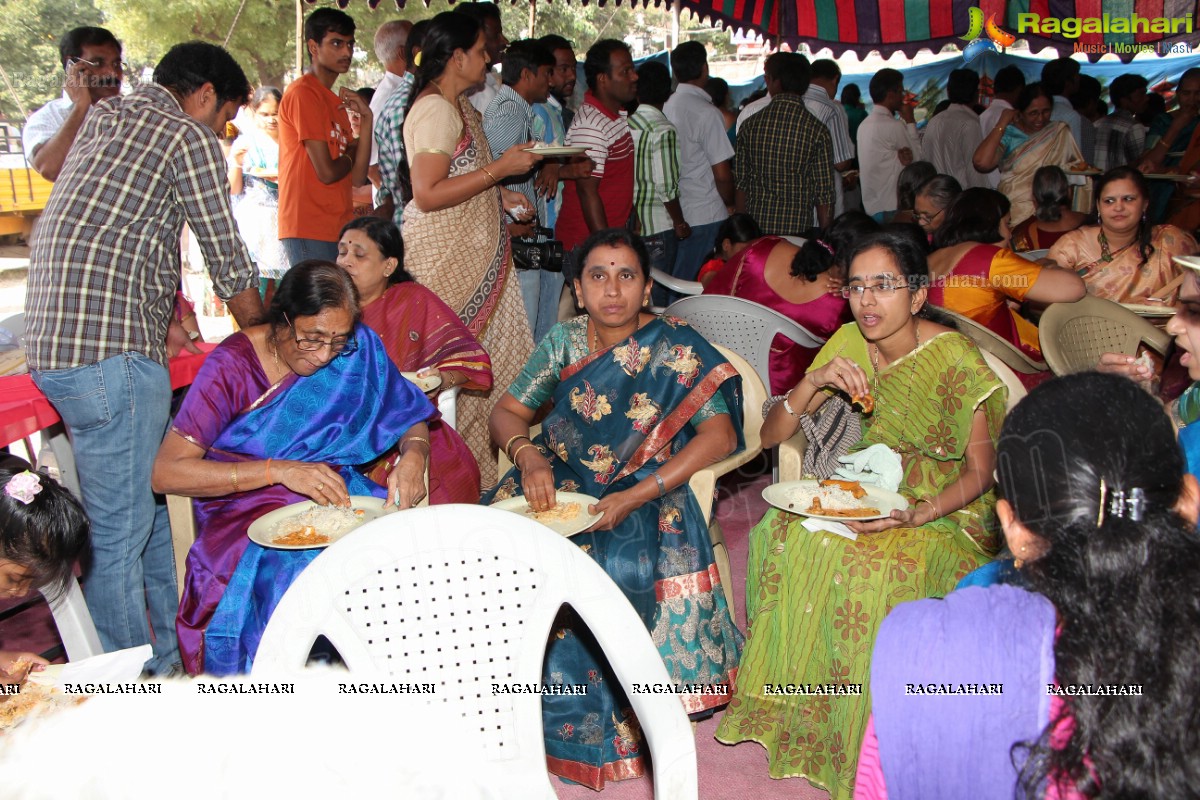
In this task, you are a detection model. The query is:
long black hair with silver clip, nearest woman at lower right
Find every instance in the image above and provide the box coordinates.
[996,372,1200,798]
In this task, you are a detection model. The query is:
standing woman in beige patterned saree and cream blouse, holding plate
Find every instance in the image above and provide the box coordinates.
[403,12,541,487]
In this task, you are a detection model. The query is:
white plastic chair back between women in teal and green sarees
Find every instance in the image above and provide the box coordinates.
[664,295,826,386]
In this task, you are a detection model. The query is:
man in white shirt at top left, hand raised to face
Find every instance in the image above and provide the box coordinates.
[22,28,125,181]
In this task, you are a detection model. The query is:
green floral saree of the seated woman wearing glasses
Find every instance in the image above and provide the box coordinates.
[716,324,1007,800]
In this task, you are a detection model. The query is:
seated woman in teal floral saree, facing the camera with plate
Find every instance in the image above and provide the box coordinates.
[485,228,743,789]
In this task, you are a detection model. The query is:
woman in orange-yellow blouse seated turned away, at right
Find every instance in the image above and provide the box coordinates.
[929,188,1087,360]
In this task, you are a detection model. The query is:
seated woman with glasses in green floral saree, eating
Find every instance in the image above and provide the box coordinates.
[716,229,1007,800]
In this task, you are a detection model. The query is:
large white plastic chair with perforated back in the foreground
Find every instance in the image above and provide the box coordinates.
[252,505,698,800]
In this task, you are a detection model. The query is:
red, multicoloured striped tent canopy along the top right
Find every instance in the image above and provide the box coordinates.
[324,0,1200,61]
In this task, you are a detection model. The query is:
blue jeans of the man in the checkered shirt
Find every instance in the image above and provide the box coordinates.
[34,353,180,672]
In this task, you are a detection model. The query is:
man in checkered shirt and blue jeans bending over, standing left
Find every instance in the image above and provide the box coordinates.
[25,42,263,674]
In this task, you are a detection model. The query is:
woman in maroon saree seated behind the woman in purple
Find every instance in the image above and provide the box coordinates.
[337,217,492,504]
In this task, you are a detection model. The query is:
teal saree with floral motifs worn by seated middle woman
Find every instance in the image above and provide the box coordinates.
[485,320,744,789]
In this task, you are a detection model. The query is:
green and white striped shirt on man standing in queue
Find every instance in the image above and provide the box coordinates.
[629,103,679,236]
